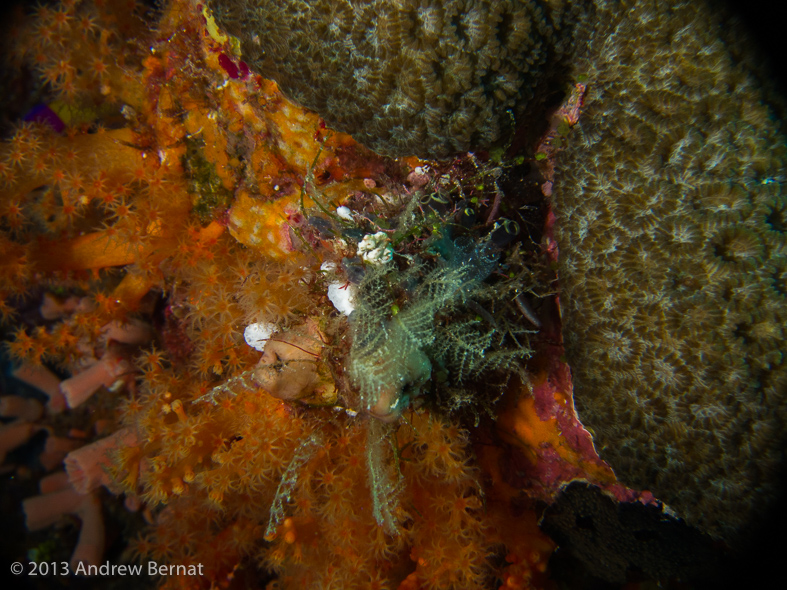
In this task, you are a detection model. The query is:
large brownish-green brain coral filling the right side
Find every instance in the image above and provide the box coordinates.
[555,0,787,539]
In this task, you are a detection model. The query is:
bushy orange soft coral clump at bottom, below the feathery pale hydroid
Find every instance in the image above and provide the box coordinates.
[115,382,502,588]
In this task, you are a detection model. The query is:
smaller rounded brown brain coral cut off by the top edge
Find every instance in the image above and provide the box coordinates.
[209,0,582,158]
